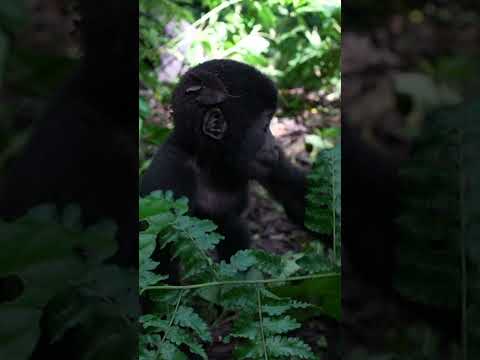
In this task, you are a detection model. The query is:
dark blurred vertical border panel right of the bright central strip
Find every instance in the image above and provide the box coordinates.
[342,0,480,359]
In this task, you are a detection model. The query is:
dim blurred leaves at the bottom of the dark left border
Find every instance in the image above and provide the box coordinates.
[0,205,139,360]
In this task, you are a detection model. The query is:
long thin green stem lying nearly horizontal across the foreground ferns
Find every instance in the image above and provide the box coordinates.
[140,273,338,295]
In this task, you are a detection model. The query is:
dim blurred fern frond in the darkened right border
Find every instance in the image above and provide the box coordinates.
[395,101,480,359]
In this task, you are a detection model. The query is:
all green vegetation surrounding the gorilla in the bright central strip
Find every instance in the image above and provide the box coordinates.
[139,0,341,360]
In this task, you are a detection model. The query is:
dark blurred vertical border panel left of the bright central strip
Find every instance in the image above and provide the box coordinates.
[0,0,139,360]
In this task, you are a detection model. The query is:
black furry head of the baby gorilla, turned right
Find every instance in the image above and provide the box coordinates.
[172,60,277,173]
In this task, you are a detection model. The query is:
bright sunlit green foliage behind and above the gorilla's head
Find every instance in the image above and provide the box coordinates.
[140,0,341,89]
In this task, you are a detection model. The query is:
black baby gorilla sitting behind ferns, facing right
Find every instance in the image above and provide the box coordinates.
[140,60,306,278]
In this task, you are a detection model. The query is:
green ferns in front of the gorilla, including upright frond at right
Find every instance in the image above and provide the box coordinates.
[139,145,341,360]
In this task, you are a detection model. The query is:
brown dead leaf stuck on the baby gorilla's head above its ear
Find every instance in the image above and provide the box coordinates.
[185,71,228,105]
